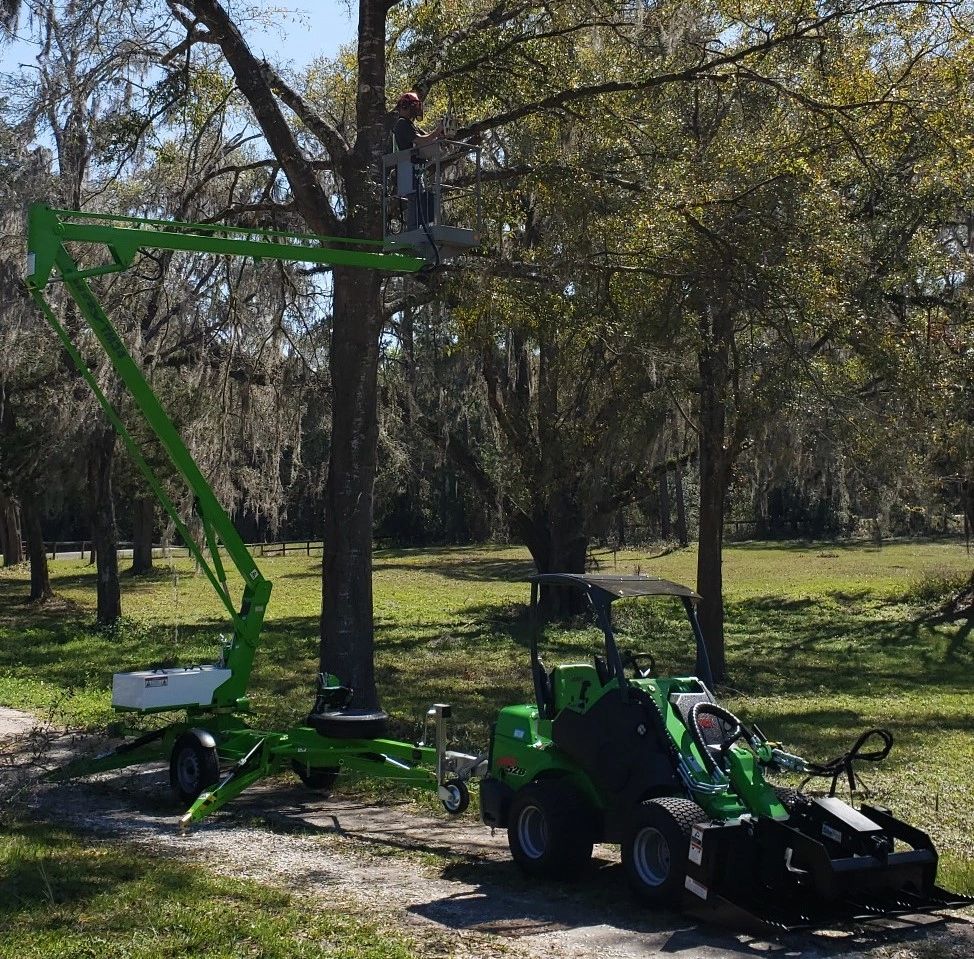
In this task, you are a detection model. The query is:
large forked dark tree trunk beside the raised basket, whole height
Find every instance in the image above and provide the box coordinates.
[177,0,389,707]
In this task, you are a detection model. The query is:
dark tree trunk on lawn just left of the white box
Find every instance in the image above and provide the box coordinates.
[88,427,122,626]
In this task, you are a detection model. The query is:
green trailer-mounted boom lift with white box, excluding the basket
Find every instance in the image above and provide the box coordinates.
[26,195,481,825]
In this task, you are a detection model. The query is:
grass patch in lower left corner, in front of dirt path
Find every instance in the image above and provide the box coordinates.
[0,824,423,959]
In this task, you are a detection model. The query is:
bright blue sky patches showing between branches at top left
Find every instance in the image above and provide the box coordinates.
[0,0,355,73]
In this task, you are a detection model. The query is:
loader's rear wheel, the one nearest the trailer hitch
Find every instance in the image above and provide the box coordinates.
[507,779,594,879]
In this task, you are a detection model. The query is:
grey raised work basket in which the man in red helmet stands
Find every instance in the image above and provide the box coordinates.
[381,139,483,266]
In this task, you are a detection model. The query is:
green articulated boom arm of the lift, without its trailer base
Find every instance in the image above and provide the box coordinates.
[25,204,427,711]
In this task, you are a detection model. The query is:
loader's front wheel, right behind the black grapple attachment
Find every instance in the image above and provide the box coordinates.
[622,798,708,906]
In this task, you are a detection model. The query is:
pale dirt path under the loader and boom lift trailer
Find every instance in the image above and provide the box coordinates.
[0,709,974,959]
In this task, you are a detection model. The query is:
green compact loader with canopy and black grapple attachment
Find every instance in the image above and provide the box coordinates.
[480,573,972,931]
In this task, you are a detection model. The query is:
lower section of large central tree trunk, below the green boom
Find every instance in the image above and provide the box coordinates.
[321,269,382,708]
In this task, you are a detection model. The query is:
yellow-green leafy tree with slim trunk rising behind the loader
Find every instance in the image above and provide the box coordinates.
[400,2,966,676]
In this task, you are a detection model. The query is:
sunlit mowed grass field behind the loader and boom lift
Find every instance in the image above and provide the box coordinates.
[0,542,974,892]
